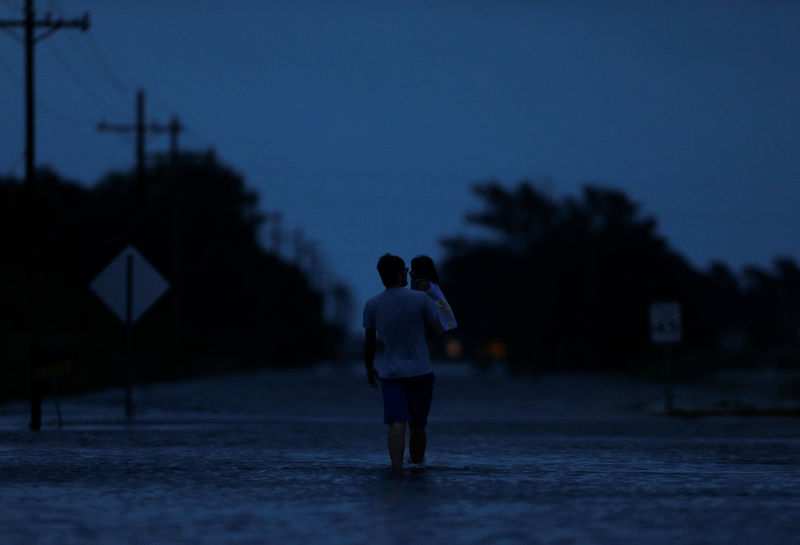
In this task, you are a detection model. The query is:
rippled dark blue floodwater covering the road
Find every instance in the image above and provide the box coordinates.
[0,365,800,545]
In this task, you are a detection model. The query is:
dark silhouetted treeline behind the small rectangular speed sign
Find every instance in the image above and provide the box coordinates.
[442,182,800,375]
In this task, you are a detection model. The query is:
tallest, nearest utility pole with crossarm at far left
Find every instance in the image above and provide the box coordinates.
[0,0,89,430]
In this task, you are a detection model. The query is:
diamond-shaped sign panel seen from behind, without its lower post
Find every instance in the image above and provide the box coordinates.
[91,246,169,324]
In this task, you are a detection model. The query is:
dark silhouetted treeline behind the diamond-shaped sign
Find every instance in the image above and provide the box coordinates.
[0,153,338,399]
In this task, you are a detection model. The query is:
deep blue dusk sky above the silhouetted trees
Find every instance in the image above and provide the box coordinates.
[0,0,800,328]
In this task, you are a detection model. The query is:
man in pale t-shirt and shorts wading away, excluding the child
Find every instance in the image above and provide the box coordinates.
[364,254,442,472]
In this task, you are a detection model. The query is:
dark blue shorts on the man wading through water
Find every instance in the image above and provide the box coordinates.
[381,373,436,426]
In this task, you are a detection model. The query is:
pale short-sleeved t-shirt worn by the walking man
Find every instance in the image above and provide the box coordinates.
[364,288,437,378]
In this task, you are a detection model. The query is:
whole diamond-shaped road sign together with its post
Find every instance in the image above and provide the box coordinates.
[91,246,169,418]
